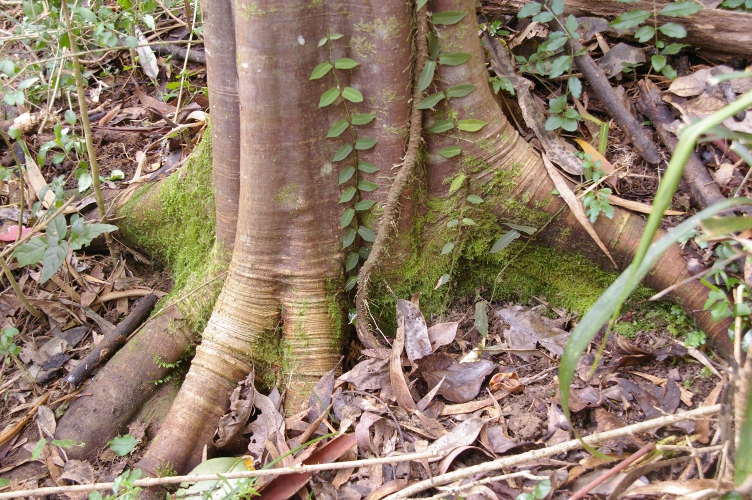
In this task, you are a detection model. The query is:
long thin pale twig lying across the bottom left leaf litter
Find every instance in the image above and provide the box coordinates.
[0,450,449,500]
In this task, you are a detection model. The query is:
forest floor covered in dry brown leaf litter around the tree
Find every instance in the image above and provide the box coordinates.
[0,0,752,500]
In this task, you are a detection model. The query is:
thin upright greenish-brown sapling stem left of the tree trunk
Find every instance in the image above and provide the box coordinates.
[60,2,118,261]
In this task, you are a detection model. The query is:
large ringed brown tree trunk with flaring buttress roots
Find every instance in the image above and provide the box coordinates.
[55,0,724,474]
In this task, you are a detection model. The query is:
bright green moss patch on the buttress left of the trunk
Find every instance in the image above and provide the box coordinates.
[121,125,229,331]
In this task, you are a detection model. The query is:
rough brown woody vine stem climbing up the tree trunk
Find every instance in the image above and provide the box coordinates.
[355,6,428,349]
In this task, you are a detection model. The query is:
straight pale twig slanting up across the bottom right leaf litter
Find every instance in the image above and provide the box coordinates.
[384,405,721,500]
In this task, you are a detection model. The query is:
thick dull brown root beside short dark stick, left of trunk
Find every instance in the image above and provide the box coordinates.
[55,307,196,460]
